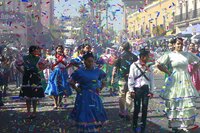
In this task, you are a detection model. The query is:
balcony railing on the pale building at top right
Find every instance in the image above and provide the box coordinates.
[174,9,200,22]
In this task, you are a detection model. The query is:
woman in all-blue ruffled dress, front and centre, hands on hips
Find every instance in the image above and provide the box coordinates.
[70,53,108,133]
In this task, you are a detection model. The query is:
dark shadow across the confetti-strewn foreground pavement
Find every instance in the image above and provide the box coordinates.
[0,108,172,133]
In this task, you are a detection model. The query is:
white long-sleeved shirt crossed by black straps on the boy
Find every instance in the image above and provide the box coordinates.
[128,61,154,92]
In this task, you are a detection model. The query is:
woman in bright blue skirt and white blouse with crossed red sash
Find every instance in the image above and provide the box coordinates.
[45,45,72,109]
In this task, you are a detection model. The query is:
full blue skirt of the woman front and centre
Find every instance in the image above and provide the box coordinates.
[70,90,108,133]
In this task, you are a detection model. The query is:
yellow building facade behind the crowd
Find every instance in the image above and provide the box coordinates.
[127,0,176,40]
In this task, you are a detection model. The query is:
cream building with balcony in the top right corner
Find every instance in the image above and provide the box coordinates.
[175,0,200,33]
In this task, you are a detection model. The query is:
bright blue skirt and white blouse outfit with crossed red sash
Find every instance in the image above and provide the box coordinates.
[45,56,72,96]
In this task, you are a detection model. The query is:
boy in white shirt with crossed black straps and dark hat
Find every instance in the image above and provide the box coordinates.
[128,48,154,133]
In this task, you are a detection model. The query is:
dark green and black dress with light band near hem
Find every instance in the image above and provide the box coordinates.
[18,54,44,98]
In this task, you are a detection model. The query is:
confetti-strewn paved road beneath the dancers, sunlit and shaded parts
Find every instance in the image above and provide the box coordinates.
[0,75,200,133]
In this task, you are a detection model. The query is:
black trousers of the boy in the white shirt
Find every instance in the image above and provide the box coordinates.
[133,85,149,130]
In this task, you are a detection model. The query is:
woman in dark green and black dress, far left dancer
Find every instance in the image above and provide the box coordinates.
[16,45,47,119]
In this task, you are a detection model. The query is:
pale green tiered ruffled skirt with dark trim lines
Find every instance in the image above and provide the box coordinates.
[160,71,199,128]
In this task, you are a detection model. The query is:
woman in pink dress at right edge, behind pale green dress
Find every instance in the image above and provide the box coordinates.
[188,43,200,93]
